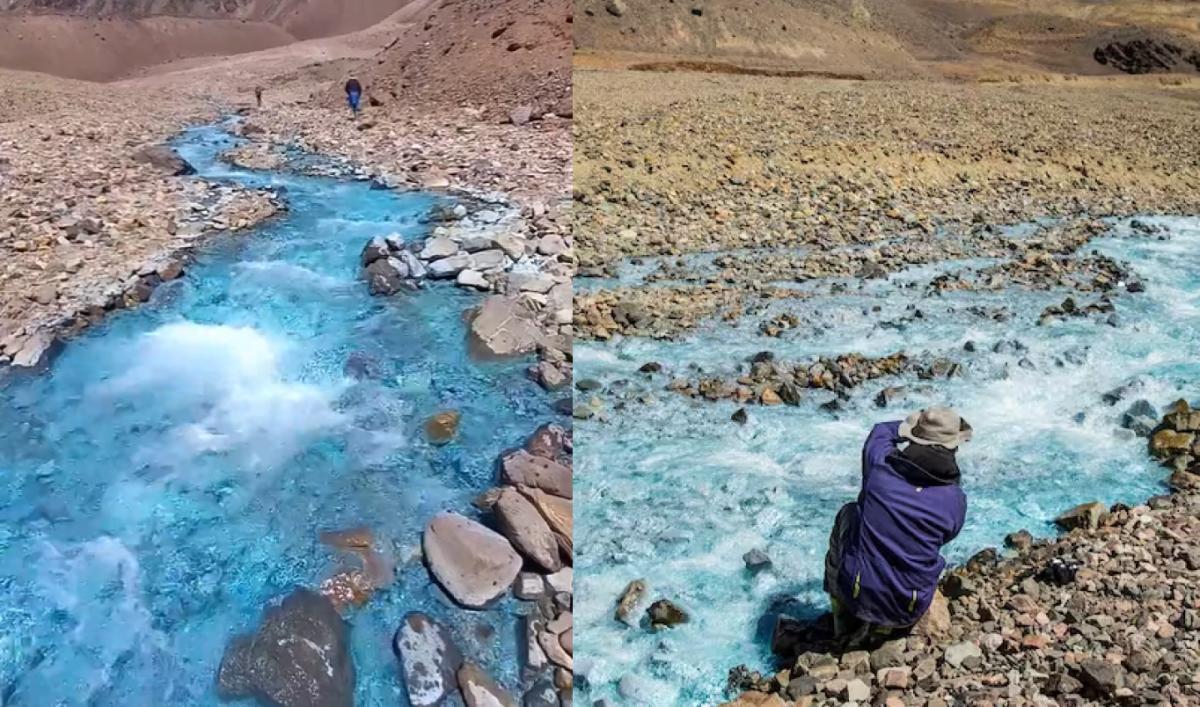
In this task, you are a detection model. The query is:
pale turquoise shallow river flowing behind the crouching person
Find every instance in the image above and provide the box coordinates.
[575,218,1200,705]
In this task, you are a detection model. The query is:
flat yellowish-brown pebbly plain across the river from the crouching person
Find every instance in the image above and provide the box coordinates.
[574,72,1200,338]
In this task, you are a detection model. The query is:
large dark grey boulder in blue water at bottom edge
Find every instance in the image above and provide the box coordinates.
[217,589,354,707]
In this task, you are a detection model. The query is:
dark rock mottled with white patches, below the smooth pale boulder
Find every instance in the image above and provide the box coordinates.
[392,612,463,707]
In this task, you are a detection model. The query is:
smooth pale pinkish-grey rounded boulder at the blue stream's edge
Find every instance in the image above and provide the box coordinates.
[422,511,522,609]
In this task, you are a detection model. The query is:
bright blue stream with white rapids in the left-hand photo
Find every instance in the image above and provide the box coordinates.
[0,128,553,707]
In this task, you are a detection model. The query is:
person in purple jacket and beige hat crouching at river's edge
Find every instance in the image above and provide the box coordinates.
[824,407,971,649]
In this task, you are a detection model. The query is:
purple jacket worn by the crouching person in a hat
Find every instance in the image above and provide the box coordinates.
[838,421,967,627]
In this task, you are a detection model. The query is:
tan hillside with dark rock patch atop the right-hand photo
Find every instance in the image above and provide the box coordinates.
[575,0,1200,78]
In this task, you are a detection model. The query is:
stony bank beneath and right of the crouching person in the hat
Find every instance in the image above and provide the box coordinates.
[710,401,1200,707]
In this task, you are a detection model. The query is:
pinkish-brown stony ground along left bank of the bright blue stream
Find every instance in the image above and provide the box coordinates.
[0,74,280,366]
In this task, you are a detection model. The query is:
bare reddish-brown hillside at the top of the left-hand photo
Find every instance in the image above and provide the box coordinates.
[0,0,409,80]
